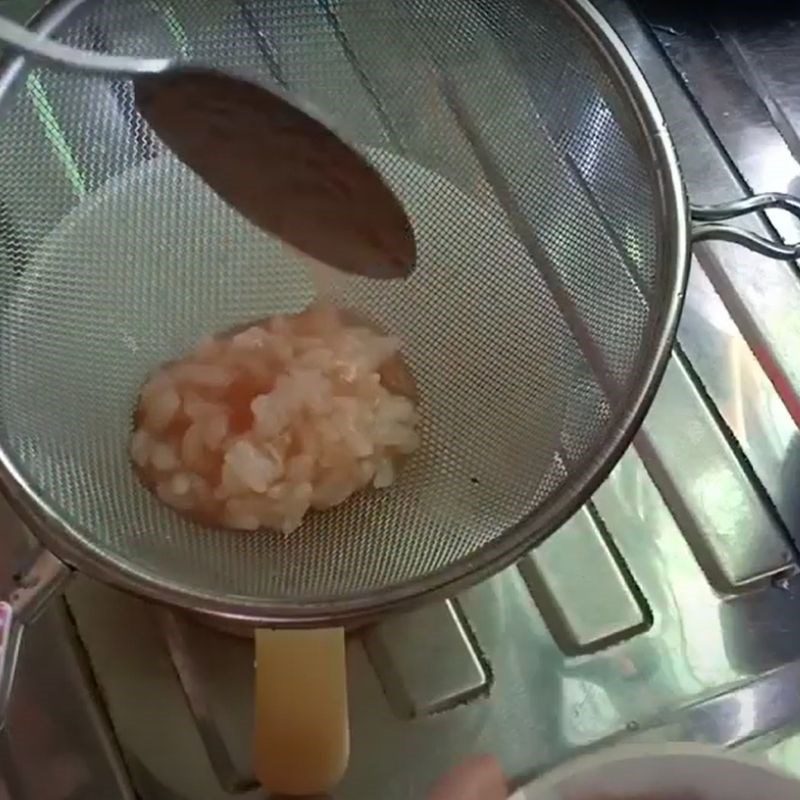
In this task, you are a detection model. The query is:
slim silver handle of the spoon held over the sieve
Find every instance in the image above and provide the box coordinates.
[0,17,174,75]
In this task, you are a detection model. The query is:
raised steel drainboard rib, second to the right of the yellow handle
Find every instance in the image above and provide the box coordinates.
[518,506,651,655]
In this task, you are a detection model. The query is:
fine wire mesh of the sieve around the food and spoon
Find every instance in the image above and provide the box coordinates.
[0,0,675,605]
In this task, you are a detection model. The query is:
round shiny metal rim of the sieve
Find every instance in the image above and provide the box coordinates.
[0,0,690,627]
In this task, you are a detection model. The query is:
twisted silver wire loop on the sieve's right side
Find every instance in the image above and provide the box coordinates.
[691,192,800,261]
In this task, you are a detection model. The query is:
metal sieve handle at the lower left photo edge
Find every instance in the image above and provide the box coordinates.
[0,550,72,730]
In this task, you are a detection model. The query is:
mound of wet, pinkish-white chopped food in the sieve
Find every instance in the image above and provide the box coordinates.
[130,306,419,533]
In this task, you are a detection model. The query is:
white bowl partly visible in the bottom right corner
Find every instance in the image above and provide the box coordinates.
[512,744,800,800]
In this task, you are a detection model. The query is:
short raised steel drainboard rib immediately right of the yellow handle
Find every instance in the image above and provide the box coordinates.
[364,602,490,719]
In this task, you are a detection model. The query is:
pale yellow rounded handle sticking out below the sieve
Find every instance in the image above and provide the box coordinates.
[253,628,350,797]
